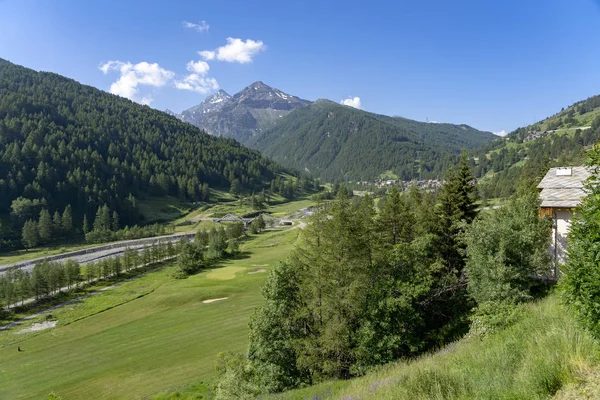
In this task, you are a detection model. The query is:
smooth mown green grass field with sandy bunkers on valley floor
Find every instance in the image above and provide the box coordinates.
[0,229,300,399]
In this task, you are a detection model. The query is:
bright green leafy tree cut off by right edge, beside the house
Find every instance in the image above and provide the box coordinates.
[560,144,600,338]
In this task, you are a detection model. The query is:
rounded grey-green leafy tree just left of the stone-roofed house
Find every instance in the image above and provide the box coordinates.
[464,191,551,330]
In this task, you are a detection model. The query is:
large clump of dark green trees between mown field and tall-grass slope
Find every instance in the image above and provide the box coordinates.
[234,183,473,392]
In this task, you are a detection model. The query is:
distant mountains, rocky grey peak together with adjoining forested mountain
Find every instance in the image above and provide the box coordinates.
[166,82,496,180]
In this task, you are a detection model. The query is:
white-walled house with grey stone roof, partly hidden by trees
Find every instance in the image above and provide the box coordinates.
[538,167,590,278]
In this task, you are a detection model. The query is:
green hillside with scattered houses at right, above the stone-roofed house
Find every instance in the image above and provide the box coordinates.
[473,96,600,197]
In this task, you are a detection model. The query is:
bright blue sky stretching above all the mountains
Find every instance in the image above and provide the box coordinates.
[0,0,600,132]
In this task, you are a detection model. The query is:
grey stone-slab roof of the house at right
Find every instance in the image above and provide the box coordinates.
[538,167,591,208]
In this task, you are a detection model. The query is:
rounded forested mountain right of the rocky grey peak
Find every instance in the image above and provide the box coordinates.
[248,100,495,181]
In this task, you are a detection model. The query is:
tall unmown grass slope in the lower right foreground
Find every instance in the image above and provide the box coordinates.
[273,295,600,400]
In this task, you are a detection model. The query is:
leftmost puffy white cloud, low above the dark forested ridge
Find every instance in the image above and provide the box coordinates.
[98,61,175,104]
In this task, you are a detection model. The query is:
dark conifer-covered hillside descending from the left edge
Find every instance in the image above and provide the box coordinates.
[0,59,279,247]
